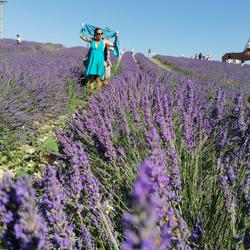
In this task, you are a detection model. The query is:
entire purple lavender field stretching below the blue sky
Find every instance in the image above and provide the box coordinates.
[0,41,250,250]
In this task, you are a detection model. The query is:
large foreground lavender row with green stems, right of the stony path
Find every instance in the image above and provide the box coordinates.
[0,53,250,249]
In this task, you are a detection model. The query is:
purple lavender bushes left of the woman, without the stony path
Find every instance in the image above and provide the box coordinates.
[0,40,86,147]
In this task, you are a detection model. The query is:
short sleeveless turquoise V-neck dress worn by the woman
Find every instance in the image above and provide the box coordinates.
[86,40,105,78]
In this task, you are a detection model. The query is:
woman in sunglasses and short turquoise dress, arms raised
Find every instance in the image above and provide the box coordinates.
[81,28,114,94]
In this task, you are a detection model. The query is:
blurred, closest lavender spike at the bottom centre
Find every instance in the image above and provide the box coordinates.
[121,161,158,250]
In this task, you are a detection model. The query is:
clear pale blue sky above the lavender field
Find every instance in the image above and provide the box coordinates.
[3,0,250,60]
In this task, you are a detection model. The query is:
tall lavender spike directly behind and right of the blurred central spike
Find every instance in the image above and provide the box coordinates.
[146,128,188,247]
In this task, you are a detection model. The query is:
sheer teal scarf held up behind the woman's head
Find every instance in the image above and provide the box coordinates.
[81,24,119,57]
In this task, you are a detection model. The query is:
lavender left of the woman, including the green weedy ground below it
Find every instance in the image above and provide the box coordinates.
[0,39,87,173]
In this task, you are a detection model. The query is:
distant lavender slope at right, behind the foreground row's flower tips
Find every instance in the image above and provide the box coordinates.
[136,53,250,112]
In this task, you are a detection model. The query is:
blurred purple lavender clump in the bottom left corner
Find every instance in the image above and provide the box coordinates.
[0,175,47,249]
